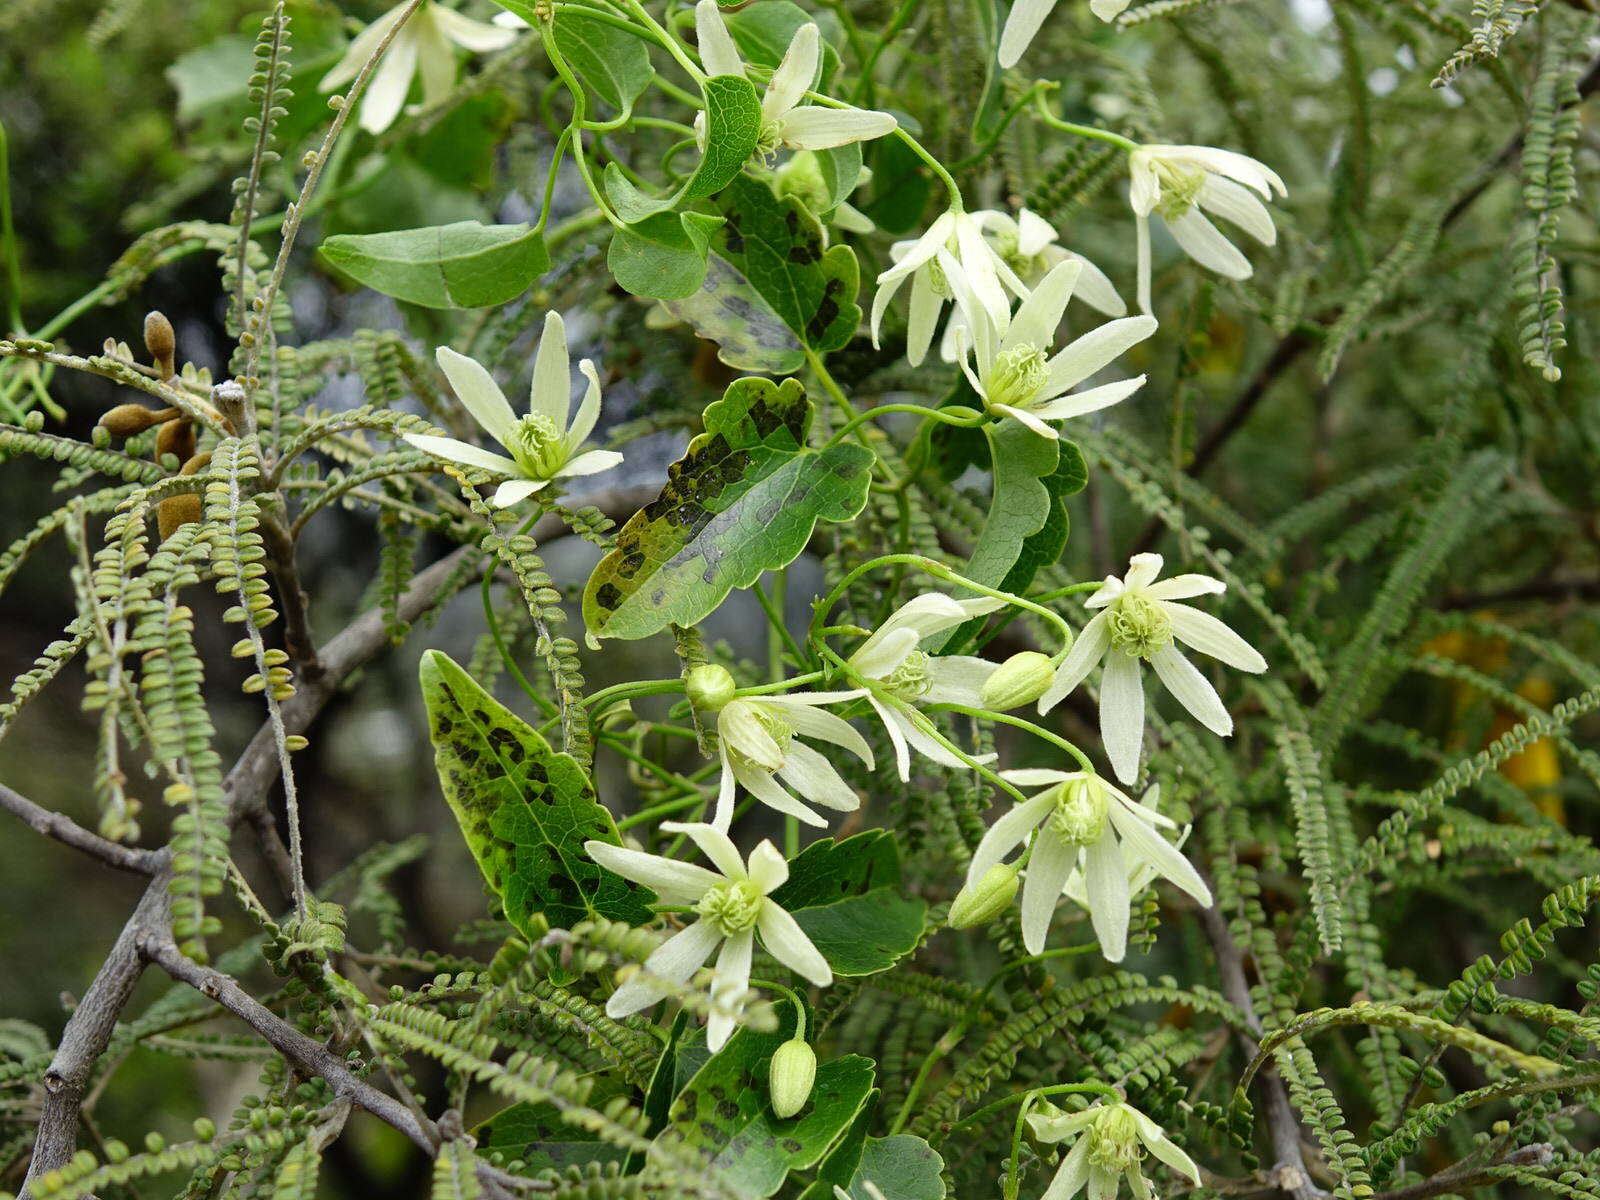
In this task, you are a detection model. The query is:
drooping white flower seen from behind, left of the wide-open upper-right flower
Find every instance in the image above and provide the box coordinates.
[872,210,1027,366]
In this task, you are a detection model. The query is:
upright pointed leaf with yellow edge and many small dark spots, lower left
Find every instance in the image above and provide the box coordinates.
[421,650,654,936]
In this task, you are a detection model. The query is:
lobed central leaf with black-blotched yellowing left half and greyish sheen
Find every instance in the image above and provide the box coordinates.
[584,379,874,638]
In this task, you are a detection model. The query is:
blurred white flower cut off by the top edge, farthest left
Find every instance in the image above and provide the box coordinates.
[318,0,517,133]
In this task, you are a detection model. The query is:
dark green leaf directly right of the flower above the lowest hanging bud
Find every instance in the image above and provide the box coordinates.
[773,829,928,976]
